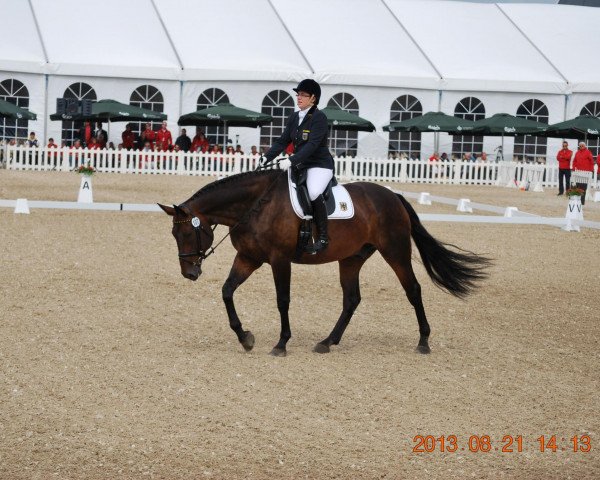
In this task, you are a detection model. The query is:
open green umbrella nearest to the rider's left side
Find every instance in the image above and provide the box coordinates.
[177,103,273,151]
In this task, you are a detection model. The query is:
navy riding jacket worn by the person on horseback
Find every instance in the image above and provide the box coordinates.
[265,106,333,170]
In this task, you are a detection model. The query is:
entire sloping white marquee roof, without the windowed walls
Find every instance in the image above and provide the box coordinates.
[0,0,600,93]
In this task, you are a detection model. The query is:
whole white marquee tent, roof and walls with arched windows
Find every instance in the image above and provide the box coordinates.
[0,0,600,161]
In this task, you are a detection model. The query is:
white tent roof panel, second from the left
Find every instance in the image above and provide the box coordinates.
[31,0,181,79]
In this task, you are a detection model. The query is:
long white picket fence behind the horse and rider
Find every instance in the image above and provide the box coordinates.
[2,146,598,191]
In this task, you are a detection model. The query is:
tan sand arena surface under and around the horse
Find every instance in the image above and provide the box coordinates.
[0,170,600,479]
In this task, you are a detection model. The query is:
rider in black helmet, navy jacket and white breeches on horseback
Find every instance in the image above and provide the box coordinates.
[265,78,333,254]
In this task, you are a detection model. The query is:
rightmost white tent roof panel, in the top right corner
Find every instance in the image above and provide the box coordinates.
[500,4,600,92]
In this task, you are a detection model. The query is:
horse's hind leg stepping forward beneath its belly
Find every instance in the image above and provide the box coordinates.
[314,249,374,353]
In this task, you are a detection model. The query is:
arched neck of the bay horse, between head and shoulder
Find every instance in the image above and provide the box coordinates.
[186,172,280,227]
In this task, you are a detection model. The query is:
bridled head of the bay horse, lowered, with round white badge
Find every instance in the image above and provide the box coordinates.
[158,203,214,281]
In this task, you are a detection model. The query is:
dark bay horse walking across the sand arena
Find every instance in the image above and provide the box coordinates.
[159,170,490,356]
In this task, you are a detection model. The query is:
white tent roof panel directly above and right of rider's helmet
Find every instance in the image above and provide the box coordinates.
[272,0,440,89]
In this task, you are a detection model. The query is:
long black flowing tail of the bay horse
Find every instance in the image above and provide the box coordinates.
[397,194,492,298]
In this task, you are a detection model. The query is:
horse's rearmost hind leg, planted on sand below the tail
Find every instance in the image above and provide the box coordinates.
[381,249,431,353]
